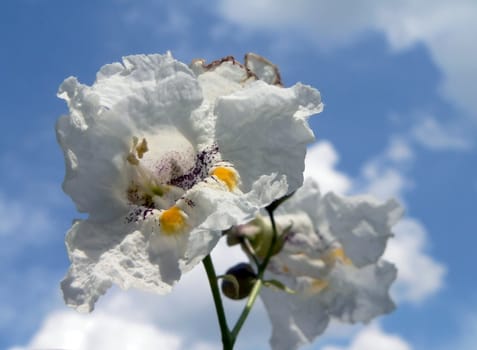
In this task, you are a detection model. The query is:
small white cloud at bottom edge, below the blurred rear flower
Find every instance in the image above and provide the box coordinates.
[322,325,412,350]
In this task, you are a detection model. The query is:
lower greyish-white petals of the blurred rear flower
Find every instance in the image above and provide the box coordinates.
[260,261,396,350]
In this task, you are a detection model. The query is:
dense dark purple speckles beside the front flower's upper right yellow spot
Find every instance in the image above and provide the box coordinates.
[168,145,219,190]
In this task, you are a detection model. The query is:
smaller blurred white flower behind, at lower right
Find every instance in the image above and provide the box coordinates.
[233,179,402,350]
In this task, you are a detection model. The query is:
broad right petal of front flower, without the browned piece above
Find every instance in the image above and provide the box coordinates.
[214,81,322,192]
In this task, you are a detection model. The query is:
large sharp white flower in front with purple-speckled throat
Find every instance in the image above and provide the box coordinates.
[57,54,322,311]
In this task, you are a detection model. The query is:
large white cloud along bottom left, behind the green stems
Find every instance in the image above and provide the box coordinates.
[10,240,269,350]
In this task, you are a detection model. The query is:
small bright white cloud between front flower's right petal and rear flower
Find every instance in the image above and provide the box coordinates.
[304,141,351,193]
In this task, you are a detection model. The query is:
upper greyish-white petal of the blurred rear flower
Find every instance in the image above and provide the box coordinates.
[277,179,403,267]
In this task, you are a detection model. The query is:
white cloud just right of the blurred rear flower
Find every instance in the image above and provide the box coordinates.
[384,218,446,303]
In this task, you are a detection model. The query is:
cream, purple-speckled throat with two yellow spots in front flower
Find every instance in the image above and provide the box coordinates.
[126,128,240,235]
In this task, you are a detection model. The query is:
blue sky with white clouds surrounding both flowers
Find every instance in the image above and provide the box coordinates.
[0,0,477,350]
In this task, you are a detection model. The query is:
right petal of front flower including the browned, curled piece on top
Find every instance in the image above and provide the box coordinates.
[191,54,323,192]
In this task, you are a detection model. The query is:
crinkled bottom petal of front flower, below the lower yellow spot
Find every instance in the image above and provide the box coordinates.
[61,215,225,312]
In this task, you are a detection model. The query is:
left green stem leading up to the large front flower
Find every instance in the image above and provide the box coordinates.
[202,255,235,350]
